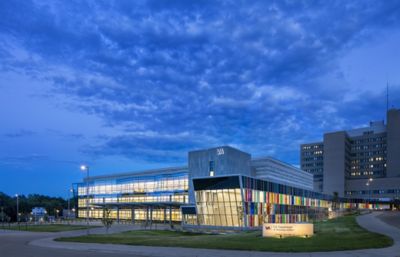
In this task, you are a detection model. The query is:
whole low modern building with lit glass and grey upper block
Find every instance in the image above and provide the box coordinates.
[76,146,378,229]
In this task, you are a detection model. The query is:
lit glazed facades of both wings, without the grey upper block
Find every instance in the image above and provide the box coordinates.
[76,165,378,228]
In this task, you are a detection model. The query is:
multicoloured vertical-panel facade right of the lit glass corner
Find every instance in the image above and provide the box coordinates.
[242,177,331,227]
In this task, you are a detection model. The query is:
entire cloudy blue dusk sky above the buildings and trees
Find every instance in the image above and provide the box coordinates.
[0,0,400,197]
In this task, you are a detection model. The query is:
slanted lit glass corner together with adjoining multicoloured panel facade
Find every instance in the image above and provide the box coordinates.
[193,176,372,228]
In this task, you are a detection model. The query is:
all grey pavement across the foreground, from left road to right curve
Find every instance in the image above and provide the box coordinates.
[0,212,400,257]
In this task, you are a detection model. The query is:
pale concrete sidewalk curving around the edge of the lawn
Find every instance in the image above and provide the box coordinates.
[30,213,400,257]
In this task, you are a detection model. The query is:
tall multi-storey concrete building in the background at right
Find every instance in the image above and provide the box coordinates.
[300,109,400,199]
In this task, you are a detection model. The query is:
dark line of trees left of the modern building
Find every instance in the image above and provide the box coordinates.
[0,192,75,222]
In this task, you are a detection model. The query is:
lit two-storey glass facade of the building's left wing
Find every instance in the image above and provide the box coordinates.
[77,172,189,221]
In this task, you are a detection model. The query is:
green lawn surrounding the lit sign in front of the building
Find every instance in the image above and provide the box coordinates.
[56,216,393,252]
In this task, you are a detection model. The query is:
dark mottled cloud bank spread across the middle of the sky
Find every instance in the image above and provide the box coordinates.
[0,0,400,168]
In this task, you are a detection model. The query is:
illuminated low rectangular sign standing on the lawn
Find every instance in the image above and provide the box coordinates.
[263,223,314,237]
